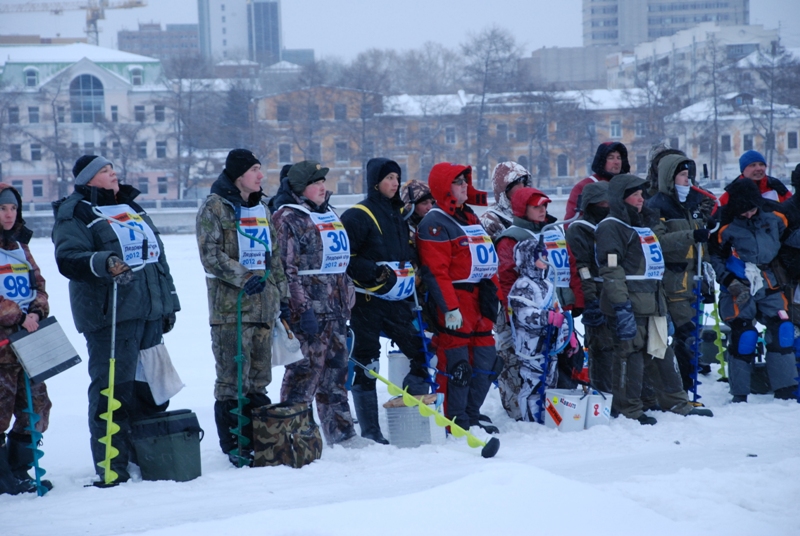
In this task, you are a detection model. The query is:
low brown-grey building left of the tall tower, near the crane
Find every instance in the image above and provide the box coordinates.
[117,22,200,60]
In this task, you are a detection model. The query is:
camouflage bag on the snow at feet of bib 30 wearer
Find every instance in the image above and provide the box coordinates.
[253,403,322,467]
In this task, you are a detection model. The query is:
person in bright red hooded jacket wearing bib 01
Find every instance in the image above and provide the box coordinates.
[417,162,502,433]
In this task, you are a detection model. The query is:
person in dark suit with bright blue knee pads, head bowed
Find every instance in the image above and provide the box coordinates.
[709,180,800,402]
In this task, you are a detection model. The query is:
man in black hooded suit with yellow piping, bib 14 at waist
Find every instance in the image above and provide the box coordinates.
[342,158,430,444]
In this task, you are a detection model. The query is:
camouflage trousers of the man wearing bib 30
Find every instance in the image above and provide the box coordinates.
[281,315,356,445]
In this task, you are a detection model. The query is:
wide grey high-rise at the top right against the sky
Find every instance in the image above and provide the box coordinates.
[583,0,750,48]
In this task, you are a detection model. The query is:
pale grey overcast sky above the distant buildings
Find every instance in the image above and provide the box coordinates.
[0,0,800,60]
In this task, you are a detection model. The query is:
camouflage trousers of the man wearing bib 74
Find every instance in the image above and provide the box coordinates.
[211,324,272,401]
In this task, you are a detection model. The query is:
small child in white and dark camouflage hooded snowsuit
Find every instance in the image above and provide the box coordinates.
[508,238,578,421]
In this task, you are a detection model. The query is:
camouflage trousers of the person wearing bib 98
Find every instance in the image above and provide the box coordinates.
[0,363,53,435]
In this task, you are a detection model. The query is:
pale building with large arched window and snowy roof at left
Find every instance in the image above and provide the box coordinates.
[0,43,177,202]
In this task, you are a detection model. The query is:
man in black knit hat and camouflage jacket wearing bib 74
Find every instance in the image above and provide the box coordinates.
[196,149,289,467]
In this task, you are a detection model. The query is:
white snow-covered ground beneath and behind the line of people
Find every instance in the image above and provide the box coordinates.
[0,235,800,536]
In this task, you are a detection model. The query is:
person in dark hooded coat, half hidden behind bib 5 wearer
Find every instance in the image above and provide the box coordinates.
[565,181,615,393]
